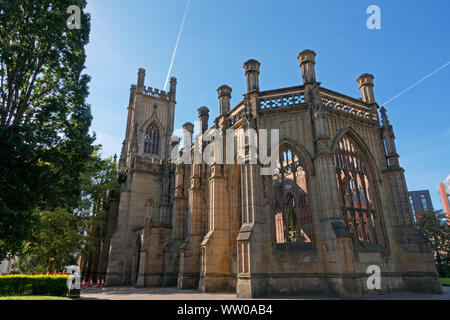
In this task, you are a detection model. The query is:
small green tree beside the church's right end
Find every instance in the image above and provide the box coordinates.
[416,210,450,273]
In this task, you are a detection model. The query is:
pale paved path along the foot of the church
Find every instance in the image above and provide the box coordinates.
[81,287,450,300]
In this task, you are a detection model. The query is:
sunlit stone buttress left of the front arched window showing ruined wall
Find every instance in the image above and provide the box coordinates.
[236,63,272,298]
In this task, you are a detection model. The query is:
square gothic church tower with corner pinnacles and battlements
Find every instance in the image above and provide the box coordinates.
[106,68,177,285]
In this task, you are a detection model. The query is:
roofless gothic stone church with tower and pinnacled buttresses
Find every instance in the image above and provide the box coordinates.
[106,50,441,298]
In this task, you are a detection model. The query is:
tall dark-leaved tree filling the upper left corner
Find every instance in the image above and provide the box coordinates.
[0,0,94,260]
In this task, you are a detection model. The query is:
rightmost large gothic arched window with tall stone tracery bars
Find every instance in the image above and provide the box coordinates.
[334,136,381,244]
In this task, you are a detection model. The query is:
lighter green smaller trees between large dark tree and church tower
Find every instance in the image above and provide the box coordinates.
[12,154,119,274]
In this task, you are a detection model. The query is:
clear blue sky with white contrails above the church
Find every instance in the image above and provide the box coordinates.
[86,0,450,209]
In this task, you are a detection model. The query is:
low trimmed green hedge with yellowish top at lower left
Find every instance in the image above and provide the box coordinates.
[0,275,70,297]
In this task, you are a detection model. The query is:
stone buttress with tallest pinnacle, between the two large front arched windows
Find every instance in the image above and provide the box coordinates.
[297,50,361,298]
